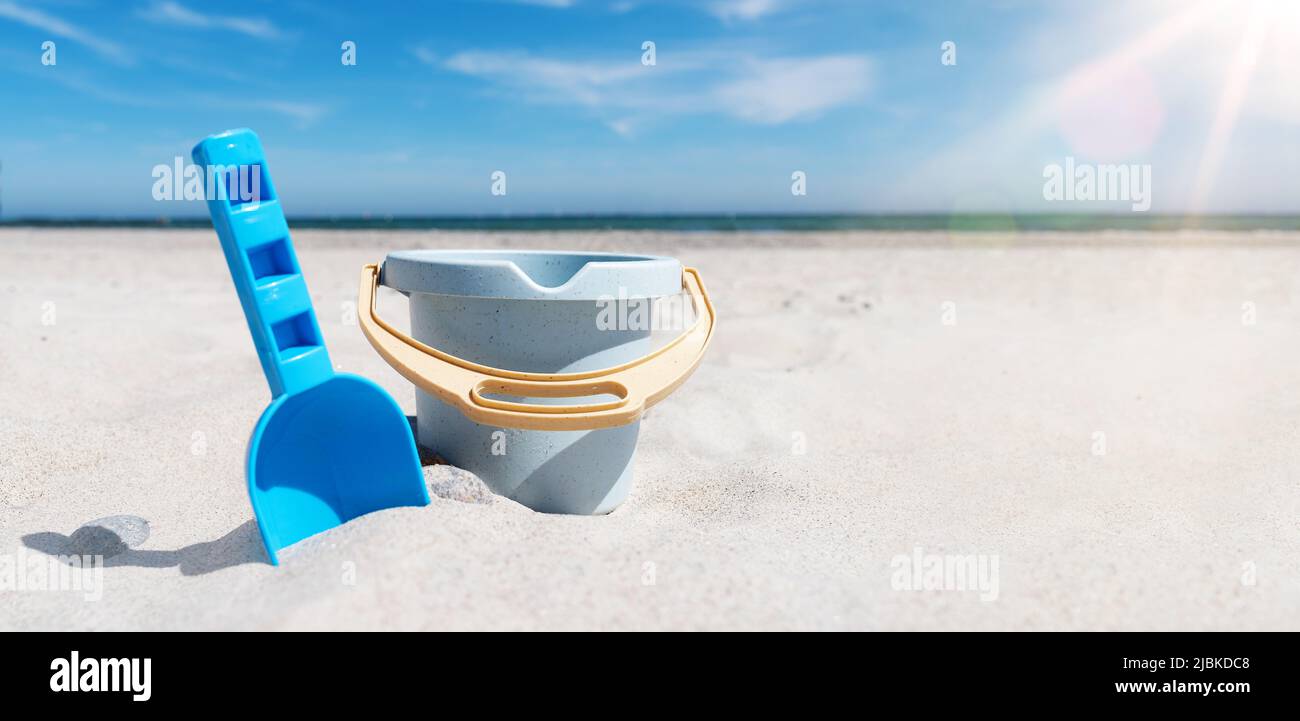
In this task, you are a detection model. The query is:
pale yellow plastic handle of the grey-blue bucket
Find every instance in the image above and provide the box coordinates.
[356,262,716,430]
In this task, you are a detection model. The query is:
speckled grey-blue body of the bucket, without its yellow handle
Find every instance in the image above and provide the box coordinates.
[381,251,681,514]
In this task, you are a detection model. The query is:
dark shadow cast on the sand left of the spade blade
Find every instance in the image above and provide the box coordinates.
[22,520,270,576]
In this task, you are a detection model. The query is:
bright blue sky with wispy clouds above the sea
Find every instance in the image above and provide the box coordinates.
[0,0,1300,217]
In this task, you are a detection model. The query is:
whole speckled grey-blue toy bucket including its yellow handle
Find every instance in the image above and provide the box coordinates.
[358,251,714,514]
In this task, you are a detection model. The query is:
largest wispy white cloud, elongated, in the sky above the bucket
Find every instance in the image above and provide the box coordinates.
[436,51,872,131]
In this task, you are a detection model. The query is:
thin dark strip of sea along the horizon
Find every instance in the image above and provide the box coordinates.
[0,213,1300,233]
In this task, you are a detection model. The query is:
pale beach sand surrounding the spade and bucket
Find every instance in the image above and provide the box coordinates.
[0,229,1300,630]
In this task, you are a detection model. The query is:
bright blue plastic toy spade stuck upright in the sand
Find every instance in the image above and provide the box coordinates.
[194,130,429,564]
